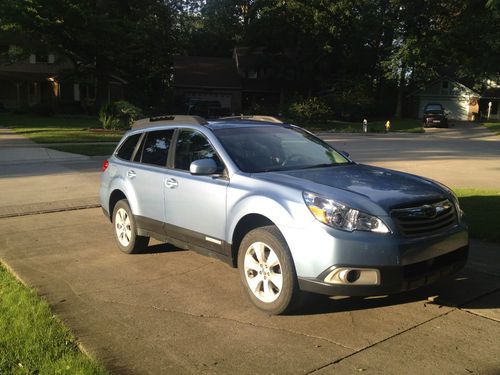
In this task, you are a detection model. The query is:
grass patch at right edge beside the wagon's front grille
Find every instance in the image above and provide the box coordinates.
[455,189,500,242]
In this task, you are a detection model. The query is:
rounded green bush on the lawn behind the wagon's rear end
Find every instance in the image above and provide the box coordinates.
[99,100,142,130]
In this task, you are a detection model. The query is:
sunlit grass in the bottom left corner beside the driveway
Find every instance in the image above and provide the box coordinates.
[0,264,107,375]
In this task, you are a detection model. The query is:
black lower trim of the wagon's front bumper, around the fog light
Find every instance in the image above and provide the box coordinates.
[299,246,469,296]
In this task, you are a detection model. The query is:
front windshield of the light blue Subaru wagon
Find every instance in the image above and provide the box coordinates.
[214,125,349,173]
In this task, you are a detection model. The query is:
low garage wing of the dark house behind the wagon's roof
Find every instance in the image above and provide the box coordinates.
[174,56,242,117]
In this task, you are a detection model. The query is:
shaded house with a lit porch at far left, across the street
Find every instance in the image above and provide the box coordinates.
[0,44,126,113]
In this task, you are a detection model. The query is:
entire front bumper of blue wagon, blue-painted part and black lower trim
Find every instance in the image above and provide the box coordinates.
[284,222,469,296]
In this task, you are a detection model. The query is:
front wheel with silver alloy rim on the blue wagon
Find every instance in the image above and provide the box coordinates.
[238,226,300,315]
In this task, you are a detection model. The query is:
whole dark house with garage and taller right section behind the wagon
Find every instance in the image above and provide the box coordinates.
[173,47,283,117]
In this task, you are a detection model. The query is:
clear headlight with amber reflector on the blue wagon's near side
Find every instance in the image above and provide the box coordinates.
[302,192,390,233]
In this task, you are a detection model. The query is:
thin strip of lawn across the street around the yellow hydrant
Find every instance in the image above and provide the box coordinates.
[292,119,424,133]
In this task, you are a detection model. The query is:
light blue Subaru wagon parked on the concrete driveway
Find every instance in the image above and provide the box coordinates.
[100,117,469,314]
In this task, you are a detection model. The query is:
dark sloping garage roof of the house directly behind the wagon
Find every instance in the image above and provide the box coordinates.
[174,56,241,90]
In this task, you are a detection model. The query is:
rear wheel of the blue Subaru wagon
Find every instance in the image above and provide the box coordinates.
[113,199,149,254]
